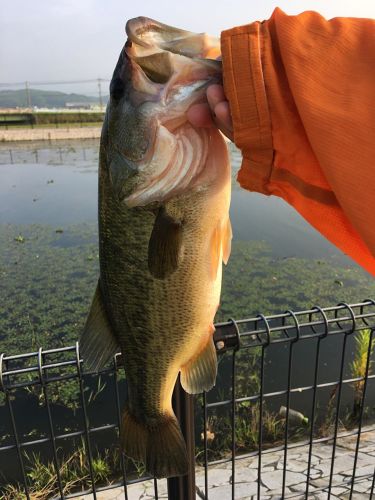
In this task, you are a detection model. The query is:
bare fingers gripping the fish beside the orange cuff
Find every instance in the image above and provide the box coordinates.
[187,84,233,141]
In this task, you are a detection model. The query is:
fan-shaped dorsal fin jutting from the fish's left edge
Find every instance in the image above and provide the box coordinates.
[80,282,119,371]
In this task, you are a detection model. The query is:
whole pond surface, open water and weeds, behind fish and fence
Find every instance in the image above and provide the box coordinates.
[0,140,375,484]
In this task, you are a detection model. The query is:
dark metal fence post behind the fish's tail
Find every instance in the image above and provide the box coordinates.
[168,378,196,500]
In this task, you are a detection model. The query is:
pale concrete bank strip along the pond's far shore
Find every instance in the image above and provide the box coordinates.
[0,126,101,142]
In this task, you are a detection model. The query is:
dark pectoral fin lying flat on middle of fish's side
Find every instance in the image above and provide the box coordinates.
[148,207,182,279]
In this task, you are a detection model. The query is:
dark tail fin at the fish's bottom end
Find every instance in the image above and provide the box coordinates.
[121,410,188,478]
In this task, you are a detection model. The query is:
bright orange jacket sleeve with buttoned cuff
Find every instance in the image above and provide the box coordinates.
[221,9,375,274]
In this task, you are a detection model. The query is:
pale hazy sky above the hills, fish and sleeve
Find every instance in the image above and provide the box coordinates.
[0,0,375,93]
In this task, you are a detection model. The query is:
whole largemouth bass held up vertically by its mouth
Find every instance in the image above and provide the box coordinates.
[81,18,232,477]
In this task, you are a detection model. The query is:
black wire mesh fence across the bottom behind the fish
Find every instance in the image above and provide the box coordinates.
[0,300,375,500]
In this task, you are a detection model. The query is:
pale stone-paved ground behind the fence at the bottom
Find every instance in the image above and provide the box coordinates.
[78,427,375,500]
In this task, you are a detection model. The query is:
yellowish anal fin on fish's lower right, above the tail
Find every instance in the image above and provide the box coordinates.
[180,335,217,394]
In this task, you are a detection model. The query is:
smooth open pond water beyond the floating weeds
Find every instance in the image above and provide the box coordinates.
[0,141,350,264]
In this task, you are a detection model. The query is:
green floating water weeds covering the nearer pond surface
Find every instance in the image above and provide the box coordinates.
[0,223,375,355]
